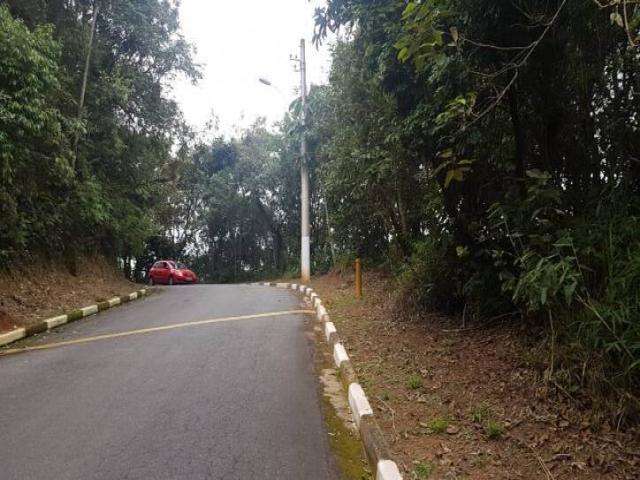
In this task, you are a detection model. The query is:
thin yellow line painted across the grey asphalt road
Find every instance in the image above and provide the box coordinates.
[0,310,315,357]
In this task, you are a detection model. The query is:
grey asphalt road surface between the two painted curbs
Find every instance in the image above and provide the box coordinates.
[0,285,339,480]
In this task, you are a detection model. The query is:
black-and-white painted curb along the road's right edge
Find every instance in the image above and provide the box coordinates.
[256,283,402,480]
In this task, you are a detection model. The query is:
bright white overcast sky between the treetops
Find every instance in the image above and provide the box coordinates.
[173,0,330,136]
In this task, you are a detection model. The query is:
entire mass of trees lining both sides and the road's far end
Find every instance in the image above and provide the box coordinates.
[0,0,640,421]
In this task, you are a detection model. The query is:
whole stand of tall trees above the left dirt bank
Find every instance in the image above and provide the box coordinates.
[0,0,198,268]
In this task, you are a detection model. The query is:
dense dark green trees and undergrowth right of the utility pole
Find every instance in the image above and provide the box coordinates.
[313,0,640,415]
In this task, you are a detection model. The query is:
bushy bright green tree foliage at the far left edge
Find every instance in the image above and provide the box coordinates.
[0,6,71,259]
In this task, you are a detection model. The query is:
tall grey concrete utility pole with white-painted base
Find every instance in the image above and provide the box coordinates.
[300,39,311,283]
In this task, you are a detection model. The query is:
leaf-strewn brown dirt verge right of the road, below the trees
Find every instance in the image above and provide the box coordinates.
[312,274,640,480]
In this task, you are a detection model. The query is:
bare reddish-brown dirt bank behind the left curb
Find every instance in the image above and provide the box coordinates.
[0,257,136,332]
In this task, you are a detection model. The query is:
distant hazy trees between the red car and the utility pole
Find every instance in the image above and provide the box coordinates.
[154,119,304,282]
